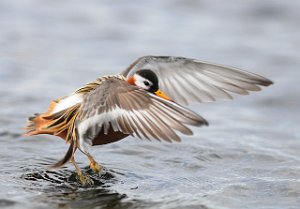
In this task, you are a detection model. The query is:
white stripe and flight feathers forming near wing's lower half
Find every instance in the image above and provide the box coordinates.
[78,90,205,141]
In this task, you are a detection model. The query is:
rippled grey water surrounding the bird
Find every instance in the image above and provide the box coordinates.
[0,0,300,209]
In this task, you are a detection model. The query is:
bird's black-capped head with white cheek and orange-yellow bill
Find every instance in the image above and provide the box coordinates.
[128,69,171,100]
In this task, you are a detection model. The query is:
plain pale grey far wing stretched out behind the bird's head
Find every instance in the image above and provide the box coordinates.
[122,56,272,104]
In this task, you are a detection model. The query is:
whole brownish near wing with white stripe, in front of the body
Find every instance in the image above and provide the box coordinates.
[77,78,207,143]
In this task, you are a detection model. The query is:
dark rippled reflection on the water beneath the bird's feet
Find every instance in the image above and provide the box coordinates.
[21,167,129,208]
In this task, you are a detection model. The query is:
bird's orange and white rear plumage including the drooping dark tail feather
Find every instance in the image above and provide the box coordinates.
[24,89,91,169]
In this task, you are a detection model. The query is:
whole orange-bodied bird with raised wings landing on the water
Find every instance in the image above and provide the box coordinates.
[25,55,273,183]
